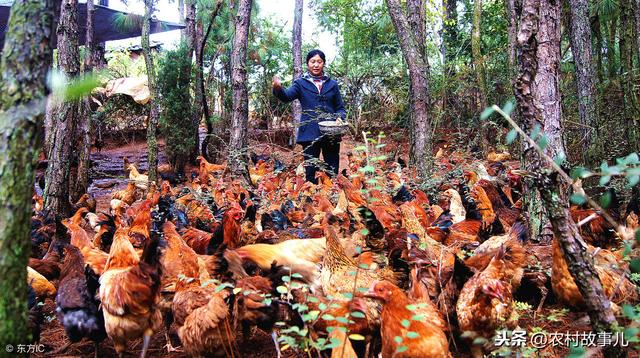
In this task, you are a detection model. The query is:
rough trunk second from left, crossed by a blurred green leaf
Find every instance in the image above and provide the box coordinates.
[44,0,81,216]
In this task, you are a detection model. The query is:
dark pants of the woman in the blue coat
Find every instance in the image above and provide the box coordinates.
[300,137,340,184]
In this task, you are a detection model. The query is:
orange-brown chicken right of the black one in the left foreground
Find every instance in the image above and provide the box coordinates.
[100,223,162,357]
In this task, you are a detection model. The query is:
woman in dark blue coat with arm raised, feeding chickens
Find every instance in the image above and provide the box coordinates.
[273,50,347,183]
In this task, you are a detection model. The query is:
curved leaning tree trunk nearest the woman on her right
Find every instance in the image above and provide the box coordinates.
[386,0,433,180]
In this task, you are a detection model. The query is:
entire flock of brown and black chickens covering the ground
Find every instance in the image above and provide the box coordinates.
[28,146,638,358]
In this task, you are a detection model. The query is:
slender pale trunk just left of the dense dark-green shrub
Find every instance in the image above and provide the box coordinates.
[142,0,160,182]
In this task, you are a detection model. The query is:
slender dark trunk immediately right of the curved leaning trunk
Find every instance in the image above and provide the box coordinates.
[441,0,458,124]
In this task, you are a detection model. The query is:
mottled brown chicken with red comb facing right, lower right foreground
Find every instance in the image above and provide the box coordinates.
[456,242,524,357]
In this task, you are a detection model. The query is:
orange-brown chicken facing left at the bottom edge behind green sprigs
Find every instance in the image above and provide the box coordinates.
[367,281,451,358]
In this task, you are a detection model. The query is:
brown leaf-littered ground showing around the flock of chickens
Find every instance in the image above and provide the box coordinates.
[34,128,638,358]
